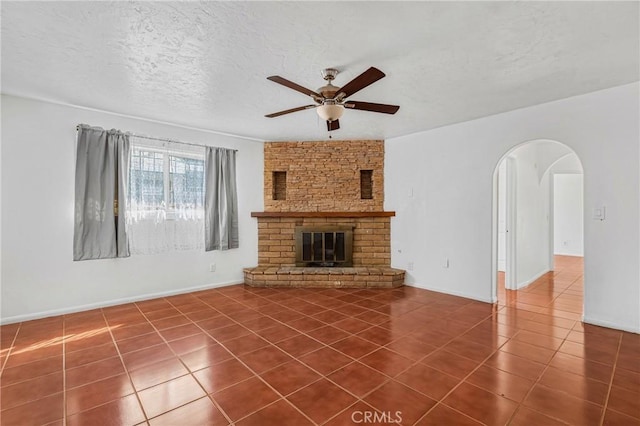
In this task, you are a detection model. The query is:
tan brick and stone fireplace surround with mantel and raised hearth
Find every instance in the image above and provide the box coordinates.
[244,140,404,287]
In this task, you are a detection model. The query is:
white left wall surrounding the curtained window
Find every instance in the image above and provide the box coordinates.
[0,95,263,322]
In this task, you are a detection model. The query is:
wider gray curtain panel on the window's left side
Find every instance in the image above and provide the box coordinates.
[73,125,129,260]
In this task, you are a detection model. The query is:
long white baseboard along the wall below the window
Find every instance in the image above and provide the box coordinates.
[0,281,244,325]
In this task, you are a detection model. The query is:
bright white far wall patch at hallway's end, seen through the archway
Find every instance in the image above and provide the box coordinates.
[553,174,584,256]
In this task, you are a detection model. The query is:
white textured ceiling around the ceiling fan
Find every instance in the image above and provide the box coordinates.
[1,1,640,140]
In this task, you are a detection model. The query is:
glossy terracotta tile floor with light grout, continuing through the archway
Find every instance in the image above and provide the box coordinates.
[0,257,640,426]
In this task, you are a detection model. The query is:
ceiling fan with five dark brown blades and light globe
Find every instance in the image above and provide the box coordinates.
[265,67,400,131]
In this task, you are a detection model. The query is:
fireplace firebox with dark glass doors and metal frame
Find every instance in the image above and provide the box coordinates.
[295,226,353,267]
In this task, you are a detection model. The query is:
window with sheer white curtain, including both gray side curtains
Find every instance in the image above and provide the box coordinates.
[73,124,239,260]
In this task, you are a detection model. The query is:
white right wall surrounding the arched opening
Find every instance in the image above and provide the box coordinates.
[385,83,640,332]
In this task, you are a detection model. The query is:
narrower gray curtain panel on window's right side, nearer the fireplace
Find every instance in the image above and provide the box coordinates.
[204,147,239,251]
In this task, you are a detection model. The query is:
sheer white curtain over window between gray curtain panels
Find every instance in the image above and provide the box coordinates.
[126,135,204,254]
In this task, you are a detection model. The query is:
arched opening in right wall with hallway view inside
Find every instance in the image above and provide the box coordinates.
[492,140,584,319]
